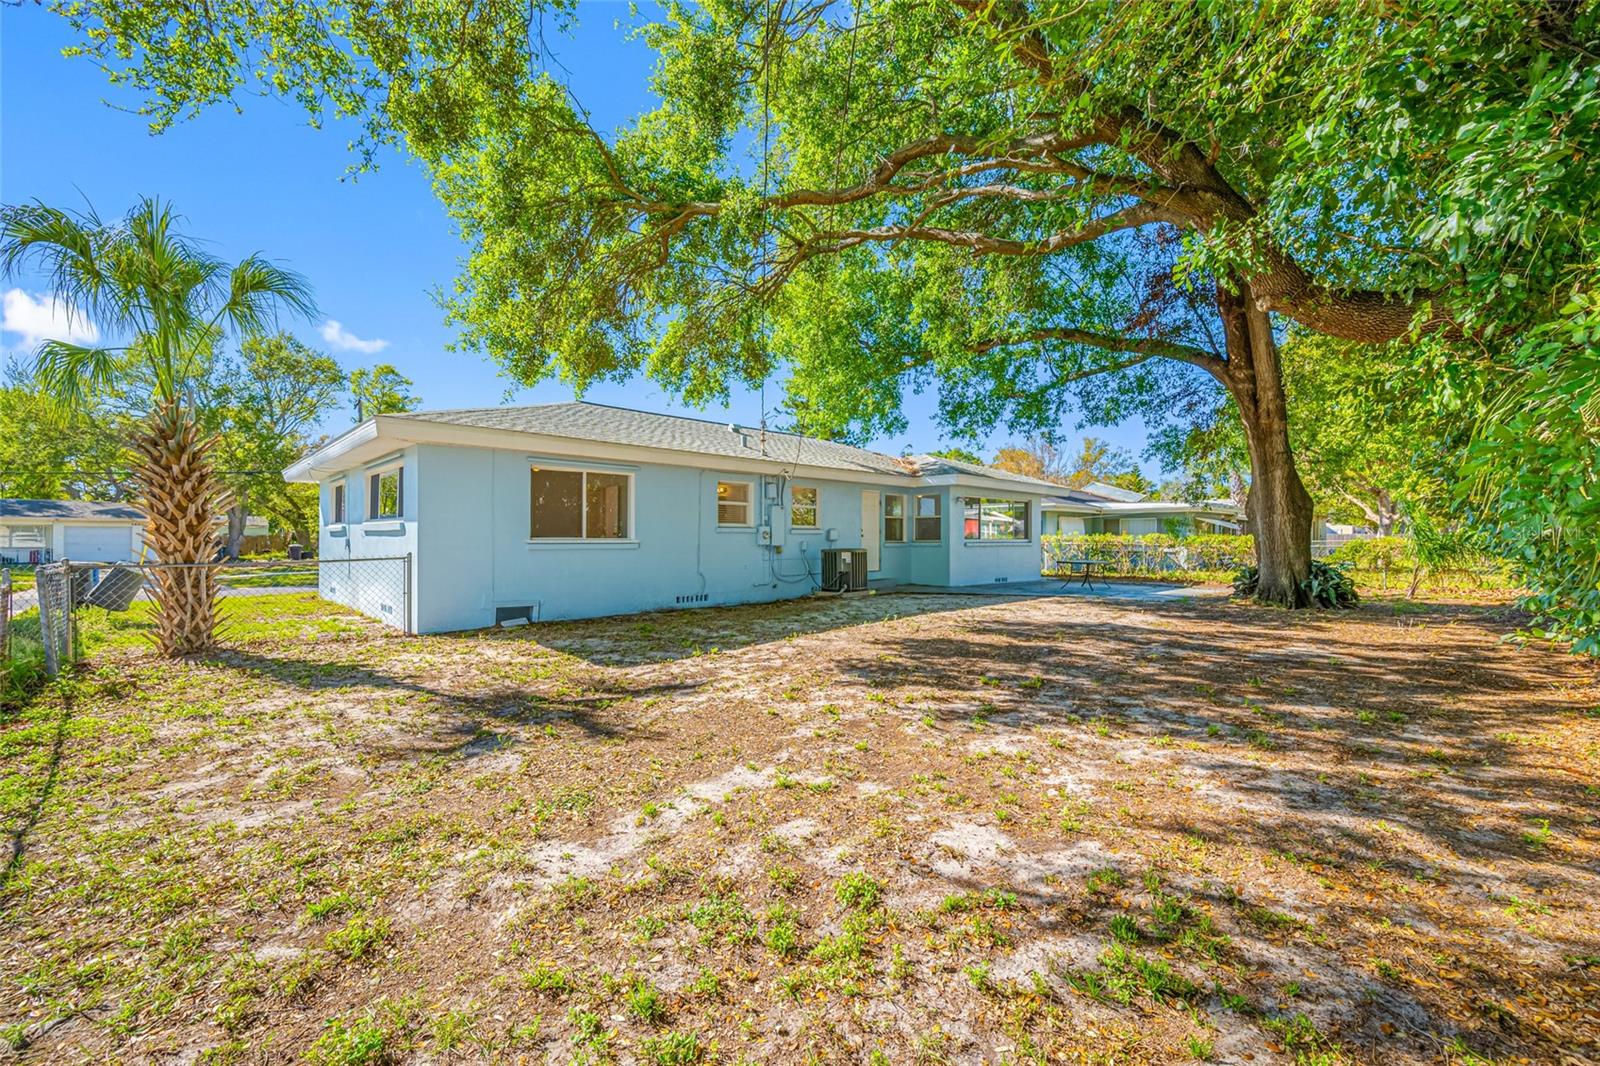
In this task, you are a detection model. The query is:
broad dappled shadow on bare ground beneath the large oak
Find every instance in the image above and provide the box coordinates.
[830,602,1600,1056]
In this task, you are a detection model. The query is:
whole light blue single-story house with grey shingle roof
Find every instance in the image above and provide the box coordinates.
[285,403,1059,632]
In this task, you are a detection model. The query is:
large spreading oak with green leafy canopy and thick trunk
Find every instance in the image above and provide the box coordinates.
[46,0,1600,624]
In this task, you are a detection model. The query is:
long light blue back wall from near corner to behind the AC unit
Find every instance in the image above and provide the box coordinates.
[400,445,870,632]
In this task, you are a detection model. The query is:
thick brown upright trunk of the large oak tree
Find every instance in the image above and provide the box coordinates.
[1218,282,1312,607]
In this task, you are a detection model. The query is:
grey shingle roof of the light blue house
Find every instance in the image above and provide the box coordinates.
[402,402,1068,488]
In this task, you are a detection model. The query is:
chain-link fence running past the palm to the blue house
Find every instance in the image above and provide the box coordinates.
[29,555,411,674]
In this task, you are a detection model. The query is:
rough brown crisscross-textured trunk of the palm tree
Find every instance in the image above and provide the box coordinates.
[133,400,227,658]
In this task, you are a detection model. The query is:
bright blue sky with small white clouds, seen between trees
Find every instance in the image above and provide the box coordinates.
[0,0,1155,474]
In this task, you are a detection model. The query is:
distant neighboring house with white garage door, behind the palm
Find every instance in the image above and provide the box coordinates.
[0,499,144,565]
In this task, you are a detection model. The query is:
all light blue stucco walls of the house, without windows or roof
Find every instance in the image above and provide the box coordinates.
[318,445,1040,632]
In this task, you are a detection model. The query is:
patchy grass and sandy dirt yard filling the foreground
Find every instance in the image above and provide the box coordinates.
[0,595,1600,1063]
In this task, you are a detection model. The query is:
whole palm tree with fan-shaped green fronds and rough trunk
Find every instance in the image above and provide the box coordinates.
[0,198,314,656]
